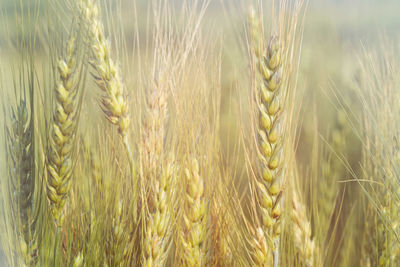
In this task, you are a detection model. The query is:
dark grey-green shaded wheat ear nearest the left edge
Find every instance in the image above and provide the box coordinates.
[6,100,38,266]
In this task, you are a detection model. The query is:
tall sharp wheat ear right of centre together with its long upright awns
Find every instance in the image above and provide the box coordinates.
[248,0,303,266]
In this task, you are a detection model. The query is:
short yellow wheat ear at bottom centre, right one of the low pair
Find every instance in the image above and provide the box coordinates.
[180,158,207,267]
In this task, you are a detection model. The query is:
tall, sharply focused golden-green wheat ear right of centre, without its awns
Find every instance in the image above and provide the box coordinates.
[257,34,283,254]
